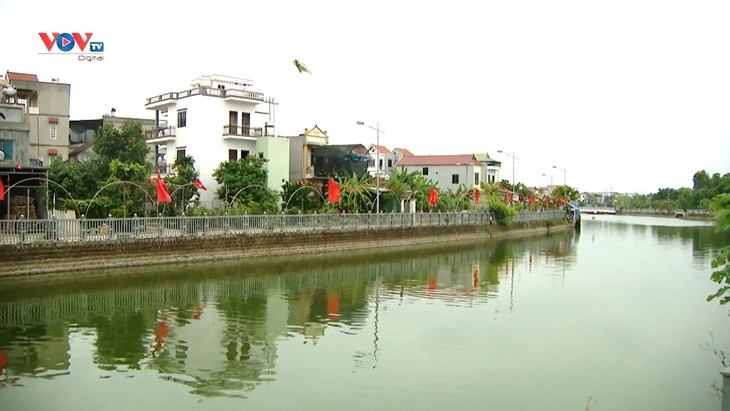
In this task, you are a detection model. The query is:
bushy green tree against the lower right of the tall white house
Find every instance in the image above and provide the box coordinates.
[213,156,279,214]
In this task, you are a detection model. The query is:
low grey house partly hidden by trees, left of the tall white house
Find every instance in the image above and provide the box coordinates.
[68,108,156,163]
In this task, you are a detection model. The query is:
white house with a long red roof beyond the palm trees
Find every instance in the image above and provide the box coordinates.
[396,154,484,190]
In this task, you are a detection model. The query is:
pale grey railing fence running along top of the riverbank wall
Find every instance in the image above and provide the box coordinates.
[0,210,566,244]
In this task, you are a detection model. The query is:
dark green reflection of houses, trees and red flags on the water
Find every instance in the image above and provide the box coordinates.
[0,233,578,397]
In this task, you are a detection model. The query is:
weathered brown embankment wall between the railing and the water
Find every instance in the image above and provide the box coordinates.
[0,220,572,278]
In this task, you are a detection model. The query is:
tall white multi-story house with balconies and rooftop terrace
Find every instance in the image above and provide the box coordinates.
[145,75,289,204]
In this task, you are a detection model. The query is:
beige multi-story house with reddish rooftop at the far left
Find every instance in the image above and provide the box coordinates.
[5,71,71,165]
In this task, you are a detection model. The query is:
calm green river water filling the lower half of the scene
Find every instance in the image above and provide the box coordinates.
[0,216,730,411]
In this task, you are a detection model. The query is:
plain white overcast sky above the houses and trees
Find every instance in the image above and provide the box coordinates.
[0,0,730,193]
